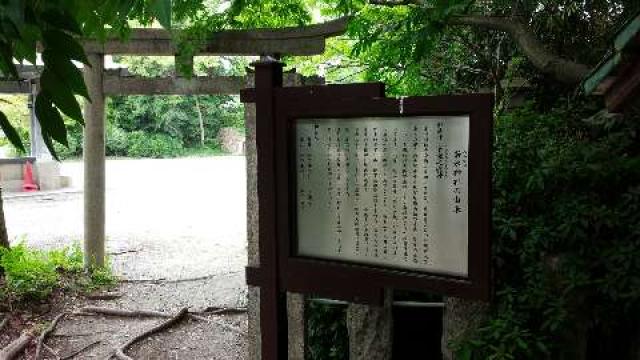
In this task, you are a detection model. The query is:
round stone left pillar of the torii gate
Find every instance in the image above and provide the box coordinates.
[83,53,105,268]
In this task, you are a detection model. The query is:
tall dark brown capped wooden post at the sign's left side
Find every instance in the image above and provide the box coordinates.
[253,58,287,360]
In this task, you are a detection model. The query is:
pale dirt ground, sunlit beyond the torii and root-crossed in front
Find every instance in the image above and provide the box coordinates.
[0,156,247,360]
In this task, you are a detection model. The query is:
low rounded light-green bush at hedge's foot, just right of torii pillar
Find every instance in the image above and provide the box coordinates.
[128,131,183,158]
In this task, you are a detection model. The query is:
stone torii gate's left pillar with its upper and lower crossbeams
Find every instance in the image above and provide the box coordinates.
[83,20,346,266]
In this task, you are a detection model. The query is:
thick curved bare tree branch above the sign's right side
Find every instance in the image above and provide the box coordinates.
[449,15,590,84]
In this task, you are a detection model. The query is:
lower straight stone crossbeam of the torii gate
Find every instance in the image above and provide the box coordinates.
[103,74,248,96]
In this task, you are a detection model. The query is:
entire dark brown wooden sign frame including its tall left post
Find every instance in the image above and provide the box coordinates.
[240,58,493,360]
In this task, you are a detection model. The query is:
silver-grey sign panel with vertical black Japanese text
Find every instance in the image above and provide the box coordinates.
[294,116,469,276]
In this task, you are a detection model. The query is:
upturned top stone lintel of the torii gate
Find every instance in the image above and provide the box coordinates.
[83,18,348,56]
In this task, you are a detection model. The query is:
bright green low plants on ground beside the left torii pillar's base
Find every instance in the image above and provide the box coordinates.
[0,243,117,306]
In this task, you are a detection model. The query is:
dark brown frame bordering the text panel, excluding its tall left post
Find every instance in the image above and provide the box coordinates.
[274,93,493,304]
